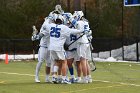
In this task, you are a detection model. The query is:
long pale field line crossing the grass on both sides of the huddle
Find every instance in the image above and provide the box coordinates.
[0,72,140,87]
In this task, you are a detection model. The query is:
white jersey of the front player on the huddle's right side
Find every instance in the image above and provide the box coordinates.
[76,20,89,43]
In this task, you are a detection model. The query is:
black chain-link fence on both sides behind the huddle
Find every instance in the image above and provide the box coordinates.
[0,38,140,61]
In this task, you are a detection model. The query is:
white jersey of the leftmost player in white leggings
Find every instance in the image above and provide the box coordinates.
[40,19,50,47]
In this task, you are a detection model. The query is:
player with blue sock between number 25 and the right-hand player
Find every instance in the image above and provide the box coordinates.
[62,13,77,83]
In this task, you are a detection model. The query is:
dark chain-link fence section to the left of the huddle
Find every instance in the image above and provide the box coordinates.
[0,39,39,59]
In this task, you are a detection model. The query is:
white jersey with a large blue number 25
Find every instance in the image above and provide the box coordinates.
[47,23,82,51]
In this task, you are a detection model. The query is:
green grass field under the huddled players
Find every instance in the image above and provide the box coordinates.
[0,61,140,93]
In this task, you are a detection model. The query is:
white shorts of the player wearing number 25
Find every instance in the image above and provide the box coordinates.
[50,50,66,61]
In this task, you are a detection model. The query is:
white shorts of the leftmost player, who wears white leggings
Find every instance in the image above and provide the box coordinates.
[38,47,51,67]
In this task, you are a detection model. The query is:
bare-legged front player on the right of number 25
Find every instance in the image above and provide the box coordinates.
[73,11,89,83]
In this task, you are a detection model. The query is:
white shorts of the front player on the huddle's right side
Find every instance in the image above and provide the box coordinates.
[76,43,89,61]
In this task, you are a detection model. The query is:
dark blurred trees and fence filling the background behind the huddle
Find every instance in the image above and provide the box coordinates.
[0,0,140,61]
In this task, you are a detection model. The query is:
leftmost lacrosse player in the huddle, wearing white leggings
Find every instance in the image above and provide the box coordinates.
[32,13,53,83]
